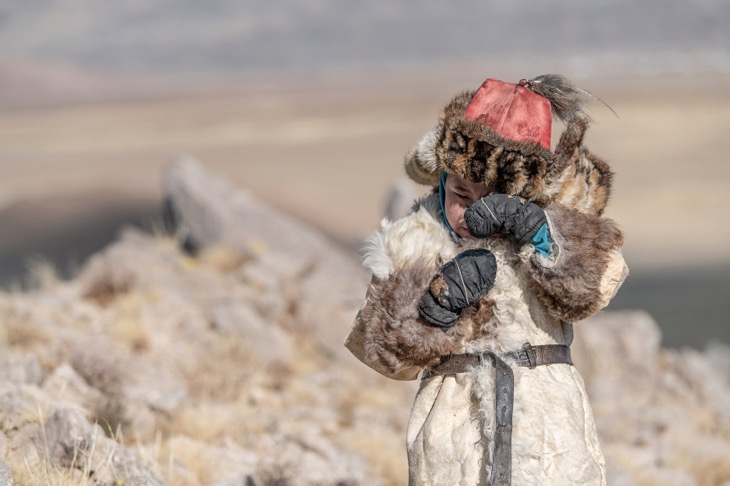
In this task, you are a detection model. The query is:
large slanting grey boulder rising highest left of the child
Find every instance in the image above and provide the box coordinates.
[163,157,367,360]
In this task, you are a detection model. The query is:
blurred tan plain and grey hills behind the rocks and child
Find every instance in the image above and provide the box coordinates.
[0,0,730,348]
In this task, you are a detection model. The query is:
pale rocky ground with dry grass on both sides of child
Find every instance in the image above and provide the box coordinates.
[0,159,730,486]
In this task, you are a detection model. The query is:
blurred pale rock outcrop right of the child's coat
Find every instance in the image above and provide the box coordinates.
[573,311,730,486]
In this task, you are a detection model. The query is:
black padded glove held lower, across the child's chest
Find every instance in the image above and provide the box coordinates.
[418,249,497,329]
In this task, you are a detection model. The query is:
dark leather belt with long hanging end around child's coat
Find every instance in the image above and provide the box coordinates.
[422,343,573,486]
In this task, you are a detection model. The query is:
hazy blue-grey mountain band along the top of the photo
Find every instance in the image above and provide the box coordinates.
[0,0,730,76]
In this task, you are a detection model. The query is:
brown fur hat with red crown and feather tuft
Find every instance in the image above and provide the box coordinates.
[405,74,612,214]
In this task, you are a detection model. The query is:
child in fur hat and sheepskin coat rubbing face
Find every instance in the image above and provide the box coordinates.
[345,75,628,485]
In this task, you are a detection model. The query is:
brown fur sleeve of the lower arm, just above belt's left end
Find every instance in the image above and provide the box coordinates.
[345,263,474,380]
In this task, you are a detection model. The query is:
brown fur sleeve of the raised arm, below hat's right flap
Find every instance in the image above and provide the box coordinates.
[528,205,628,322]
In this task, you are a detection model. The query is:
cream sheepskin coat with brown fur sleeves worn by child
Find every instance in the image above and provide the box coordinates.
[345,194,627,486]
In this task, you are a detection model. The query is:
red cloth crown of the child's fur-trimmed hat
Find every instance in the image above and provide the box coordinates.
[465,78,553,150]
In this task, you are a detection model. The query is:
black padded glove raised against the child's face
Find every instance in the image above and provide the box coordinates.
[464,194,547,246]
